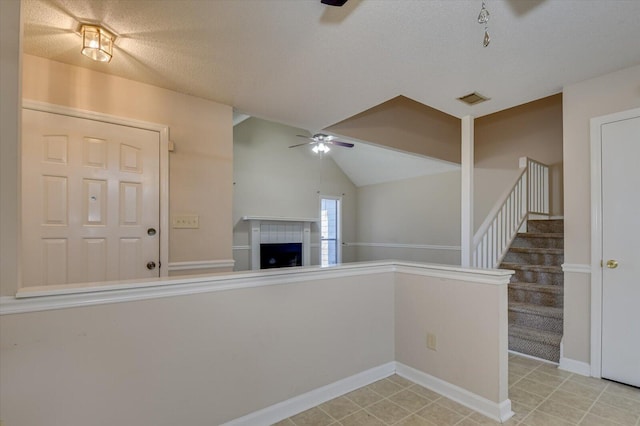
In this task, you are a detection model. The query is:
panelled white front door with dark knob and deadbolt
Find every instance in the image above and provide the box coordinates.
[22,109,160,286]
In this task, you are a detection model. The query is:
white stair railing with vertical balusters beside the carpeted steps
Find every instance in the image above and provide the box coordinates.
[471,157,549,268]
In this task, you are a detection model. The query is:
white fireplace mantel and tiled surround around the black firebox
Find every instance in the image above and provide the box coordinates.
[242,216,320,270]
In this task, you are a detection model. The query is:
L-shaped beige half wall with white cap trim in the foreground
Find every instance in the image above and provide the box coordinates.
[0,262,510,426]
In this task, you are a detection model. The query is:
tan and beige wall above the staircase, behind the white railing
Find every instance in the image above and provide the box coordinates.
[474,94,563,229]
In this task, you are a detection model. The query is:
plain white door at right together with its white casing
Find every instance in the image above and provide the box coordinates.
[591,109,640,386]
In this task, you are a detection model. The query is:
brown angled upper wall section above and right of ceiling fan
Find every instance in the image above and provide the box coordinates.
[326,96,461,163]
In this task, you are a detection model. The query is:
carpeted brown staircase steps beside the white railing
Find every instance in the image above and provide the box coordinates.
[500,220,564,362]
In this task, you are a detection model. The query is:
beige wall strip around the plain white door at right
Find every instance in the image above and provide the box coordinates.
[563,66,640,362]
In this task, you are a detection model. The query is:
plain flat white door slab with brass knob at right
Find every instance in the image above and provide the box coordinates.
[601,117,640,386]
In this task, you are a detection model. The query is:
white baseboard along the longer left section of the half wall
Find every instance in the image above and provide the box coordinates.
[222,362,396,426]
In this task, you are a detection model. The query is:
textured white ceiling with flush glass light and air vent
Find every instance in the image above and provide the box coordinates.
[22,0,640,133]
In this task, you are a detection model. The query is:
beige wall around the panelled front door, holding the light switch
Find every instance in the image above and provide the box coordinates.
[23,55,233,282]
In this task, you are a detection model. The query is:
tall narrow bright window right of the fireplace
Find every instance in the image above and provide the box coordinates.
[320,197,342,266]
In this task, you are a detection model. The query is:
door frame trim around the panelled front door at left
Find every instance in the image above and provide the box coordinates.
[19,99,169,280]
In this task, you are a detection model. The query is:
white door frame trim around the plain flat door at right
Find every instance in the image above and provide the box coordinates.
[590,108,640,377]
